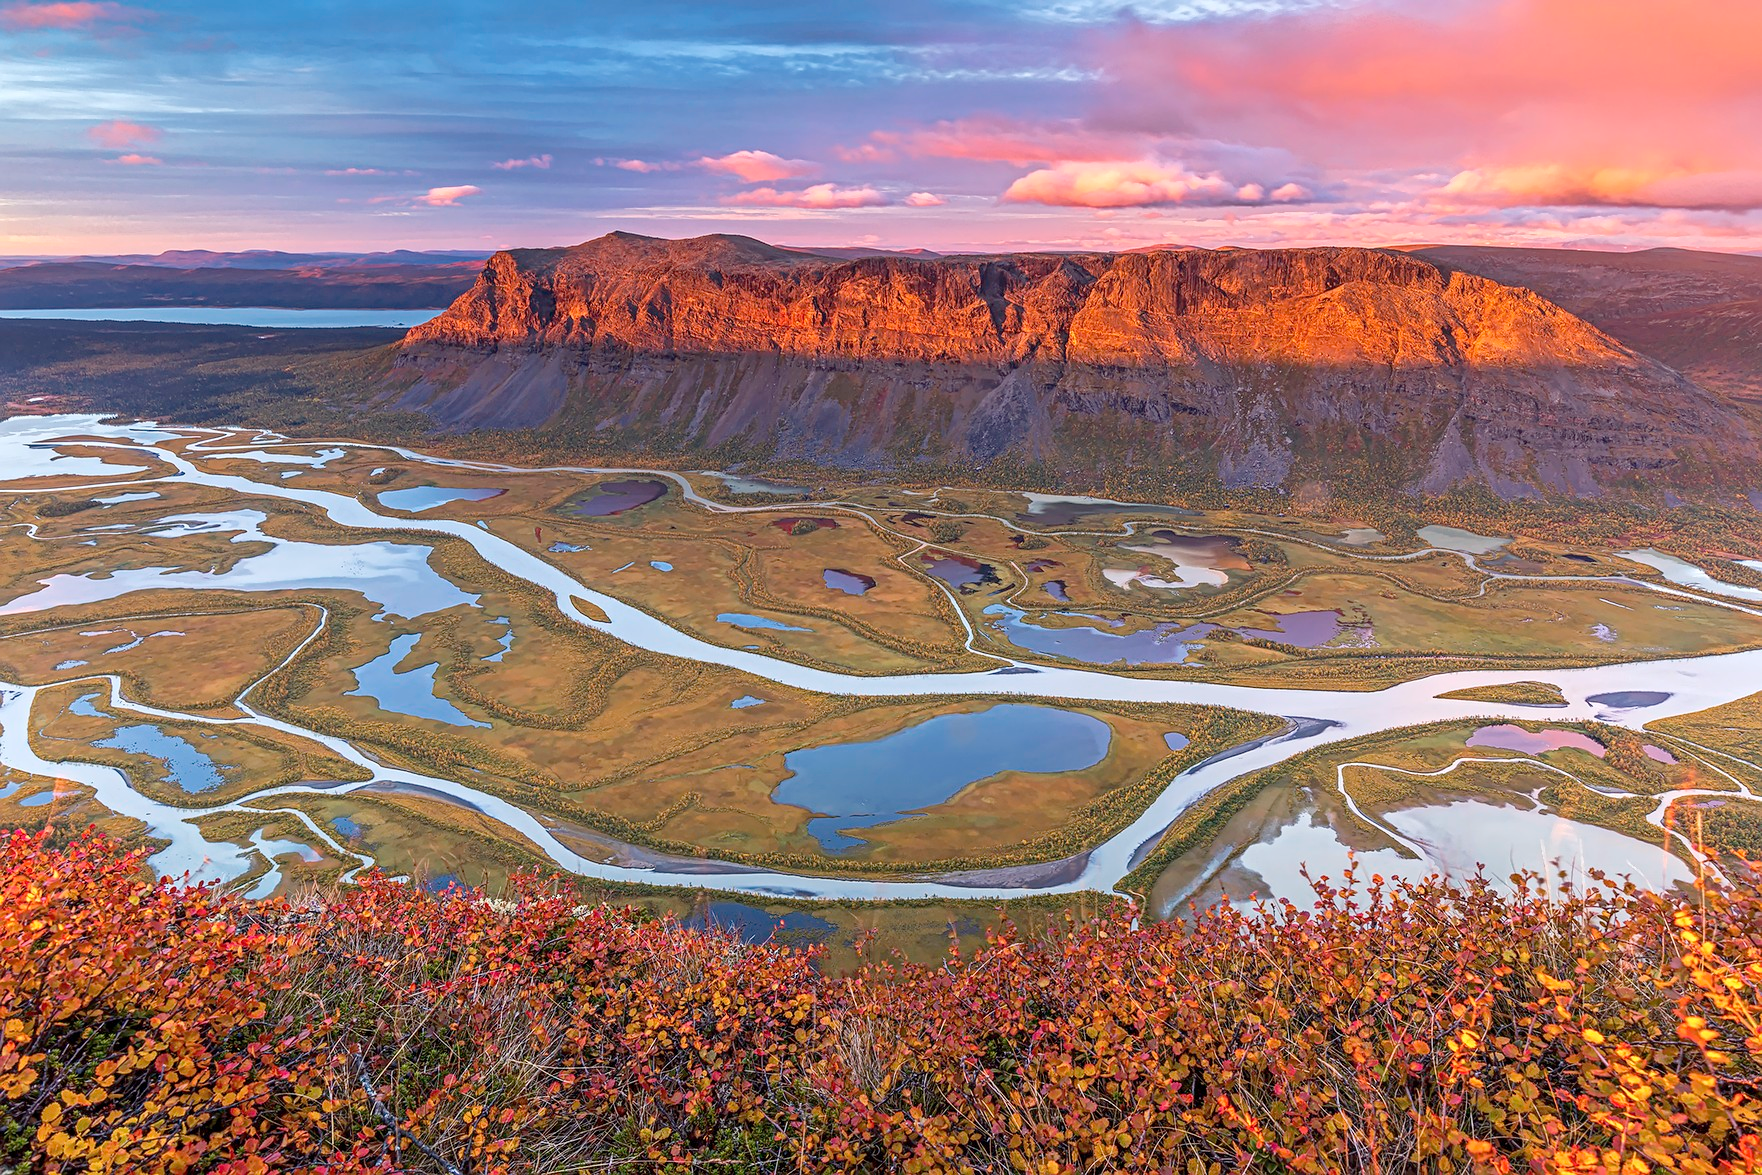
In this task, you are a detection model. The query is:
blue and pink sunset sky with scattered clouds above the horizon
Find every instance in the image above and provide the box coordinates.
[0,0,1762,255]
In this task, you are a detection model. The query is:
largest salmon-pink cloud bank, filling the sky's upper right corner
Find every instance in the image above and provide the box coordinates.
[1092,0,1762,208]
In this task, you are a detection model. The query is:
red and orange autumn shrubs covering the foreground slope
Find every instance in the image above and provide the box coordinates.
[0,833,1762,1173]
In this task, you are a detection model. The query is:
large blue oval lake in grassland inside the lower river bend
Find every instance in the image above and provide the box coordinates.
[772,703,1114,853]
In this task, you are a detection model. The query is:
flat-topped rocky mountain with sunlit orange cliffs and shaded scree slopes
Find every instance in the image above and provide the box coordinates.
[381,233,1762,495]
